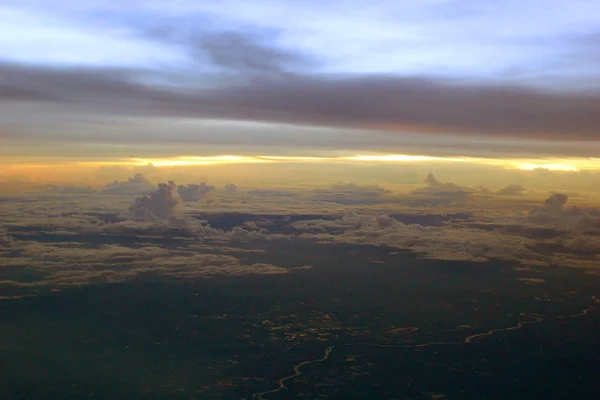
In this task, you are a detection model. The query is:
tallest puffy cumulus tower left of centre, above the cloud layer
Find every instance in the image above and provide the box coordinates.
[129,181,181,221]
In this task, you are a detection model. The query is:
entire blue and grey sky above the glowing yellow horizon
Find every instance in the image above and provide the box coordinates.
[0,0,600,185]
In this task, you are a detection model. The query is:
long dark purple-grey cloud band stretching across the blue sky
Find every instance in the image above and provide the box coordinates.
[0,61,600,147]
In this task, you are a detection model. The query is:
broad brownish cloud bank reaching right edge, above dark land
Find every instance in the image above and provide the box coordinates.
[292,196,600,268]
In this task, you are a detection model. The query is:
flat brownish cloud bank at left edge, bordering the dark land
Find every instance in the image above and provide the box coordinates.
[0,242,290,293]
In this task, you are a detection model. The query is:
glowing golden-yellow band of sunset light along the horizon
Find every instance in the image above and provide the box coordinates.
[7,153,600,188]
